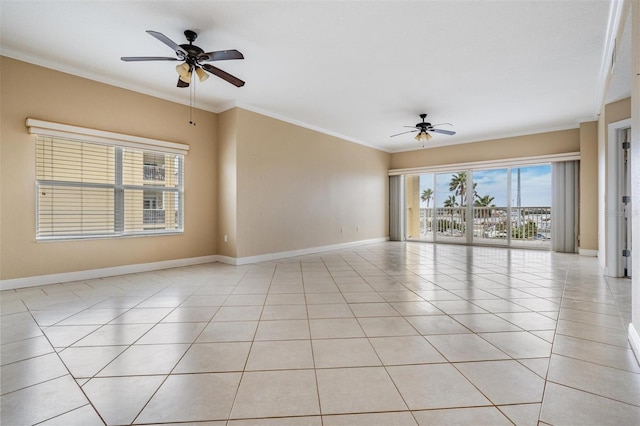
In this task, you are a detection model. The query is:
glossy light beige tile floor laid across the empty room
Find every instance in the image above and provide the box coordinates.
[0,242,640,426]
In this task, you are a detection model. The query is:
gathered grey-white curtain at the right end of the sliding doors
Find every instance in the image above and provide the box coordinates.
[551,161,580,253]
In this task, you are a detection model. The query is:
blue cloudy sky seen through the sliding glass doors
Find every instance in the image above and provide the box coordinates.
[420,164,551,207]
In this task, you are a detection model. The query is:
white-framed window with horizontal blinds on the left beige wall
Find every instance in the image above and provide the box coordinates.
[30,123,184,240]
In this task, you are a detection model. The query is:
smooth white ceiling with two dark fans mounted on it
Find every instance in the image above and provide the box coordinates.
[0,0,630,152]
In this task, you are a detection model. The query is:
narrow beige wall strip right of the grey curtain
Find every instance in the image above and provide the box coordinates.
[579,121,598,251]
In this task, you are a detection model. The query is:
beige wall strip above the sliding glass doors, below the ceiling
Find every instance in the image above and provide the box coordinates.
[391,129,580,169]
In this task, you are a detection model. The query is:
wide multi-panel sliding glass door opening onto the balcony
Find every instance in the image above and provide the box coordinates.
[405,164,551,249]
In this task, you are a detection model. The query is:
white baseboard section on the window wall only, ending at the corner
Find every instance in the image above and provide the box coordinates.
[0,256,218,290]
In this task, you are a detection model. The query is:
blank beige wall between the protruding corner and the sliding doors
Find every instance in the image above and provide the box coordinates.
[230,109,390,257]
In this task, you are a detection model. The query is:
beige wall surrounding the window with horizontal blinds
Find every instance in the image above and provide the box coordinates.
[0,57,217,279]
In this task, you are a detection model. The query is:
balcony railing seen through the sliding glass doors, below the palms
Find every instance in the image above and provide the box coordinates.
[420,206,551,246]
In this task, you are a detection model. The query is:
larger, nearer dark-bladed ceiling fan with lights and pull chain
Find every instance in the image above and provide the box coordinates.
[120,30,244,87]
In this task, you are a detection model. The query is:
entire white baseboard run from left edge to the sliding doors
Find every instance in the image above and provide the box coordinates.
[0,237,389,290]
